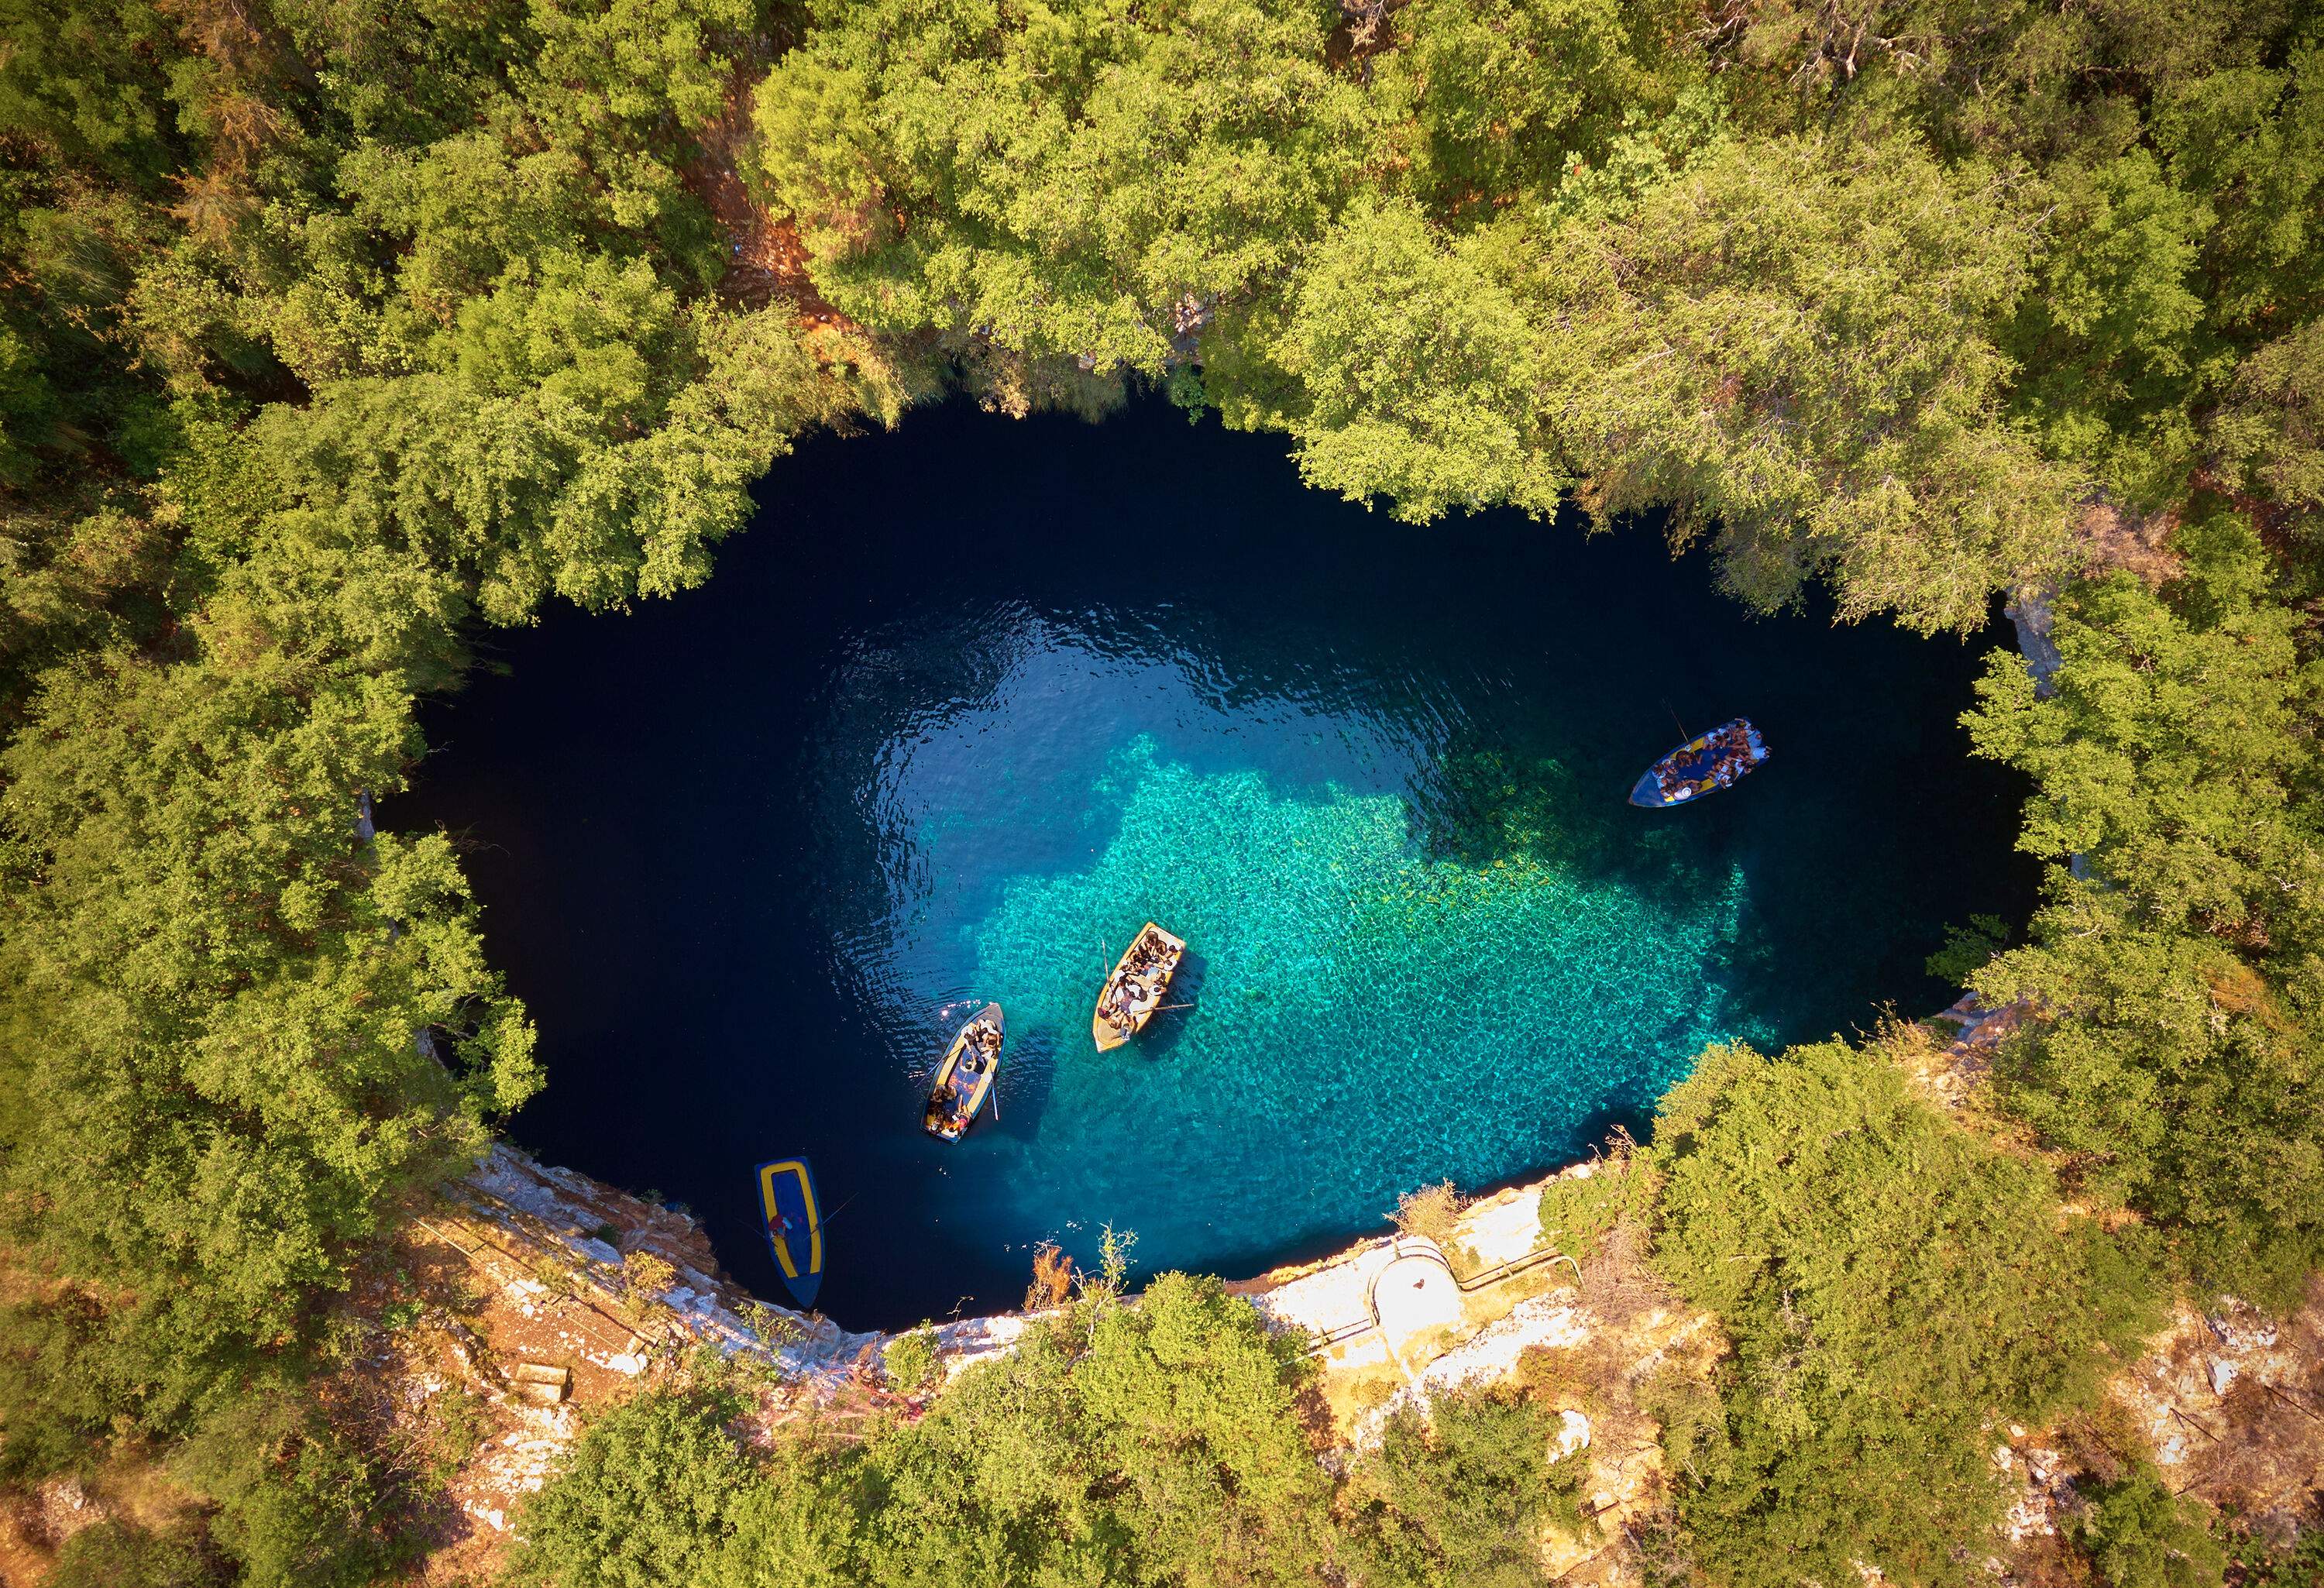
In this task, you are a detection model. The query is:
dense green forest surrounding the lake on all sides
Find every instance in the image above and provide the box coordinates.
[0,0,2324,1588]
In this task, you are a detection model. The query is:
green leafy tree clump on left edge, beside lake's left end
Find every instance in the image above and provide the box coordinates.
[0,565,539,1337]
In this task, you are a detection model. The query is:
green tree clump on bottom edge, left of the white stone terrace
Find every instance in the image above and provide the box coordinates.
[516,1274,1332,1588]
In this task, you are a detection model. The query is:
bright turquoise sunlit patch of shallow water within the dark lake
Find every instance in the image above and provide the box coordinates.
[962,737,1773,1263]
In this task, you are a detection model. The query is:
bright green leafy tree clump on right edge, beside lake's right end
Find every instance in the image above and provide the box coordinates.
[1966,511,2324,1300]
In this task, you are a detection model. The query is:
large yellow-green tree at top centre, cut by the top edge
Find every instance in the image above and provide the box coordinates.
[755,0,1373,372]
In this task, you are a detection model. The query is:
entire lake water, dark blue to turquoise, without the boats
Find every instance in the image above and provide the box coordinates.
[388,404,2033,1328]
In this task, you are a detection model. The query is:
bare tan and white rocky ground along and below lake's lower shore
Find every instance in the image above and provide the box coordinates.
[407,998,2324,1569]
